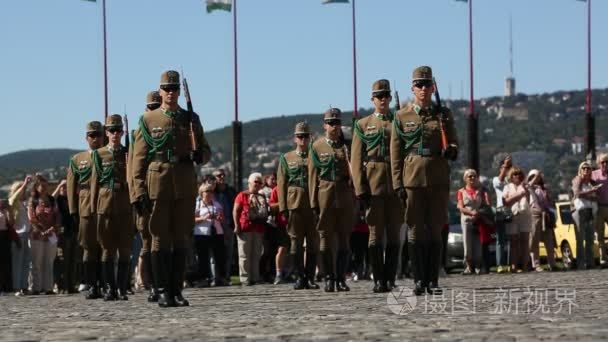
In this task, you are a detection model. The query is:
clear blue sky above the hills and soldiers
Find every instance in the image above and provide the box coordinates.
[0,0,608,154]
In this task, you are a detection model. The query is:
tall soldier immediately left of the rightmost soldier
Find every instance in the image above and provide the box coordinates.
[351,80,403,292]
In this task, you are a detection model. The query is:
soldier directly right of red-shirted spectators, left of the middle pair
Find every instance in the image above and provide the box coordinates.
[277,122,319,290]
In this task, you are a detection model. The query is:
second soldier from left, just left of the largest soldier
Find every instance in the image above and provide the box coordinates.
[91,114,134,301]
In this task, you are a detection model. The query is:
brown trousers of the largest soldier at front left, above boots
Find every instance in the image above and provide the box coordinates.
[149,197,196,252]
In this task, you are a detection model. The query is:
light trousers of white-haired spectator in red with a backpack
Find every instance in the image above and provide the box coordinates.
[237,232,264,283]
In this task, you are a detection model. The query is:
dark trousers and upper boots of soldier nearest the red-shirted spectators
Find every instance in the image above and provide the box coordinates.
[287,208,319,276]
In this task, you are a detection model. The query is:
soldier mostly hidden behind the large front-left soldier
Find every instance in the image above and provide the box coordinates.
[127,90,162,302]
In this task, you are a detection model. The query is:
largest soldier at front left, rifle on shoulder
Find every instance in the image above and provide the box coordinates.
[133,70,211,307]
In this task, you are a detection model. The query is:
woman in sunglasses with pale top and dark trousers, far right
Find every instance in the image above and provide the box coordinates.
[572,161,601,270]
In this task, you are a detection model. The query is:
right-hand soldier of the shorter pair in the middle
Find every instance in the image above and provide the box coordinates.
[308,108,355,292]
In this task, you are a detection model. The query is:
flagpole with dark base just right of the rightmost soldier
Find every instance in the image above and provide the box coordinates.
[467,0,479,172]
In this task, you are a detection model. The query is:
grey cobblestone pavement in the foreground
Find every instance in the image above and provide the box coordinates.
[0,270,608,341]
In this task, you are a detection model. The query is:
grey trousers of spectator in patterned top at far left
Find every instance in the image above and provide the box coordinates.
[32,240,57,292]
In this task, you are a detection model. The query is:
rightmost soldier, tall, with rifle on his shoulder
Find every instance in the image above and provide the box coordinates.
[391,66,458,295]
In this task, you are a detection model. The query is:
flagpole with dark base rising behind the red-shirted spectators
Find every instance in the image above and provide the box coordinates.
[232,0,243,191]
